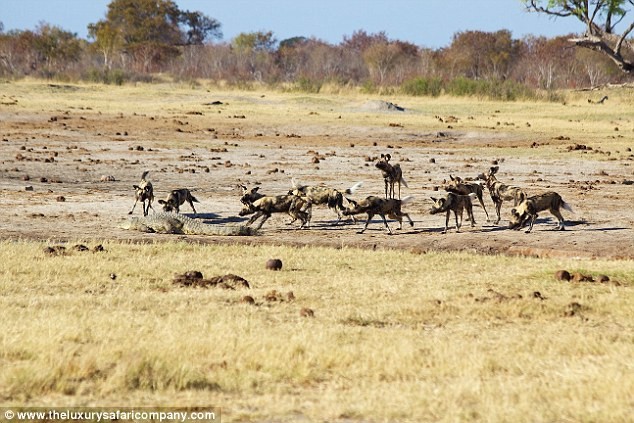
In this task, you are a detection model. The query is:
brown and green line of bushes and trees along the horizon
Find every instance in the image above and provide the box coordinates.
[0,0,627,100]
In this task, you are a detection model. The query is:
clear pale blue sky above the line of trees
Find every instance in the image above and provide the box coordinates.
[0,0,584,49]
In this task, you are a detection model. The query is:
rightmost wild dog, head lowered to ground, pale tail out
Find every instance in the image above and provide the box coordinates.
[509,191,574,233]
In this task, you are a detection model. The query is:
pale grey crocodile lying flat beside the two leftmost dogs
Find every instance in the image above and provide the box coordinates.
[119,212,257,235]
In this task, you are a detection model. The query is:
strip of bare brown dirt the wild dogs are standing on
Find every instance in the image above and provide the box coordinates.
[0,86,634,259]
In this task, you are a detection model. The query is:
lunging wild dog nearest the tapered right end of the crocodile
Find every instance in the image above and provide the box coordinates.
[239,195,312,230]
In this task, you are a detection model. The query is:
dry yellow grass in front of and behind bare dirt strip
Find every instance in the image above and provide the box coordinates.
[0,80,634,422]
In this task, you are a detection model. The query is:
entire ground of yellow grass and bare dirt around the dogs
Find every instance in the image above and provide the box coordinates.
[0,80,634,423]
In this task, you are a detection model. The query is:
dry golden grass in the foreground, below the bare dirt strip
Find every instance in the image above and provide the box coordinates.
[0,242,634,422]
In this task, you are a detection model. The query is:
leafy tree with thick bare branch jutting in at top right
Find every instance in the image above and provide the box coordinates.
[524,0,634,74]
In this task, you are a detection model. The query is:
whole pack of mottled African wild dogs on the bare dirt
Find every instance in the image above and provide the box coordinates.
[128,154,572,234]
